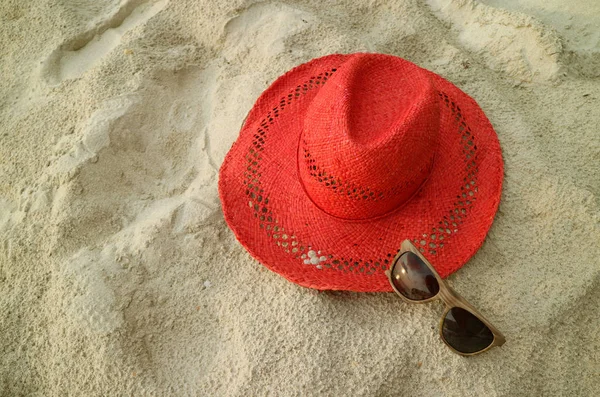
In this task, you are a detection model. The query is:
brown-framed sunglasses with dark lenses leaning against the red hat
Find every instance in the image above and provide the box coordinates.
[385,240,506,356]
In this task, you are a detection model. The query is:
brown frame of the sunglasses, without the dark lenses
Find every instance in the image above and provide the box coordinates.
[385,240,506,356]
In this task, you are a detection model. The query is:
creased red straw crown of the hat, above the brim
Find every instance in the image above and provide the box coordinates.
[298,54,440,220]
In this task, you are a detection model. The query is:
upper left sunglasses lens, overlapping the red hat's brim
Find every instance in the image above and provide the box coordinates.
[392,252,440,301]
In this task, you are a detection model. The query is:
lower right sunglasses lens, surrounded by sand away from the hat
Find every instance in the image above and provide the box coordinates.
[442,307,494,353]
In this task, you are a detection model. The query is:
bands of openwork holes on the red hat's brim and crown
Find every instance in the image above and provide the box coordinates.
[244,77,478,275]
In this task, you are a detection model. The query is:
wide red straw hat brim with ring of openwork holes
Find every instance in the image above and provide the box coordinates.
[219,54,503,292]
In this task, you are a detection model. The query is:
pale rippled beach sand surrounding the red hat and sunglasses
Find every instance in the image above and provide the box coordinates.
[0,0,600,396]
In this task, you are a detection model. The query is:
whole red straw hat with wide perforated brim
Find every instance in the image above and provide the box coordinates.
[219,53,503,291]
